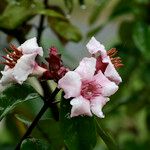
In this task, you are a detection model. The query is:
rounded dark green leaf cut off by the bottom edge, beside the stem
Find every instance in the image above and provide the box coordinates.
[21,138,49,150]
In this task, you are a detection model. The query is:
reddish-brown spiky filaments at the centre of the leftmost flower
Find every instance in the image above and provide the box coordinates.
[0,44,23,68]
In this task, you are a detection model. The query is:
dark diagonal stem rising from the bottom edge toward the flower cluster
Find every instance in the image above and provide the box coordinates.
[15,88,60,150]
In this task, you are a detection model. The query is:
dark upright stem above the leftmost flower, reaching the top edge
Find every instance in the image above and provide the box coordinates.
[37,0,48,44]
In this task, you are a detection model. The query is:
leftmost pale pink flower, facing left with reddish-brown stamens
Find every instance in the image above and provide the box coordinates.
[0,37,46,85]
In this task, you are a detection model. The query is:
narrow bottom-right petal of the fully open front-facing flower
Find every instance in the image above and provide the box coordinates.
[91,96,109,118]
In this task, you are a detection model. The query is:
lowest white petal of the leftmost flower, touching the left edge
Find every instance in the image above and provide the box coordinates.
[0,69,16,86]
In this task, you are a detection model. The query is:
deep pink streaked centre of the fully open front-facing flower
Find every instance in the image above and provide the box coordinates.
[81,81,101,100]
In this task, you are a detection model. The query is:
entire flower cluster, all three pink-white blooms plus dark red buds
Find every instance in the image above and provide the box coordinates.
[0,37,122,118]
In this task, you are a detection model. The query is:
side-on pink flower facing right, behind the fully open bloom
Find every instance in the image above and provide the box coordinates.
[86,37,123,85]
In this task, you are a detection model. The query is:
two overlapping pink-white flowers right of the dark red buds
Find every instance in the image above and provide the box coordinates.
[58,37,122,118]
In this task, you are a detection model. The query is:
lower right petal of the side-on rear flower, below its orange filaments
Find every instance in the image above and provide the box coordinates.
[103,56,122,85]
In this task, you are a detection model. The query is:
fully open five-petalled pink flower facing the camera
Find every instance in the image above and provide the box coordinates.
[58,57,118,118]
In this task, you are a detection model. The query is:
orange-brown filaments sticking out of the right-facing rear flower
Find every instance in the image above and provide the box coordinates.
[107,48,123,68]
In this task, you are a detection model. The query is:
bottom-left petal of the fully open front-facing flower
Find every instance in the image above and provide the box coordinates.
[70,96,92,117]
